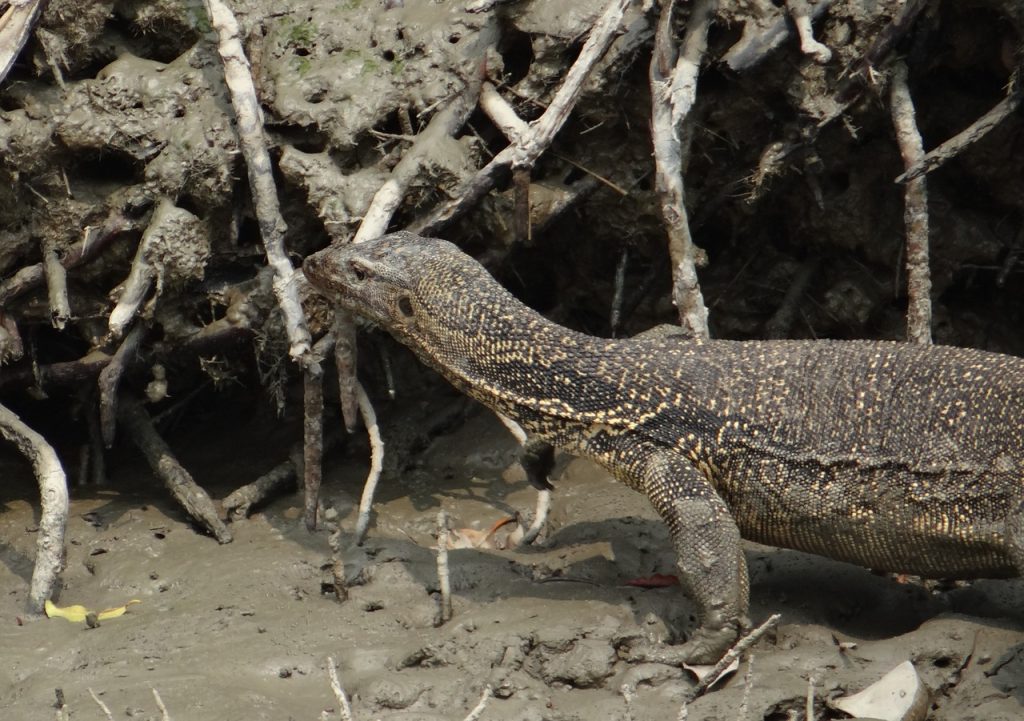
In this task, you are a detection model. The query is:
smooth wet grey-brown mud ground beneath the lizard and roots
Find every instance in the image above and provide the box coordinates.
[0,408,1024,721]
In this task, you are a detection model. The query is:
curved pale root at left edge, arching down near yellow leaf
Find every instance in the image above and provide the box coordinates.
[0,406,68,613]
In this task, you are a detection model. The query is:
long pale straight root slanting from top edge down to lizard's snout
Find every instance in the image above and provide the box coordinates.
[205,0,312,364]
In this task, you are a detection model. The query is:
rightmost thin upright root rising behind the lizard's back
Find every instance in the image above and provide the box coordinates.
[889,60,932,345]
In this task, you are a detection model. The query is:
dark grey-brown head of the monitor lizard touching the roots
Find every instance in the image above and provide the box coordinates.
[302,231,497,348]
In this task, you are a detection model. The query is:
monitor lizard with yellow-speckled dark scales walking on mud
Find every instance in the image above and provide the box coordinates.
[303,232,1024,663]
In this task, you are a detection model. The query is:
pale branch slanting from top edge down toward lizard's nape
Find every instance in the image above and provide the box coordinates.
[410,0,629,236]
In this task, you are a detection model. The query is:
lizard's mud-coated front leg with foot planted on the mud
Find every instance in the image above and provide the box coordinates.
[634,450,750,664]
